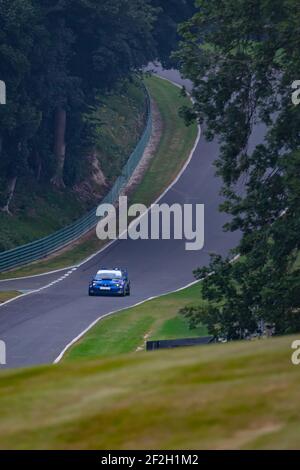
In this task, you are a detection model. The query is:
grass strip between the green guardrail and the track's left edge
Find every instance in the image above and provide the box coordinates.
[0,76,197,279]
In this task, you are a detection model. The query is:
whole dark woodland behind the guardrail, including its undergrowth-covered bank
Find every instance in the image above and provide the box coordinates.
[0,0,193,249]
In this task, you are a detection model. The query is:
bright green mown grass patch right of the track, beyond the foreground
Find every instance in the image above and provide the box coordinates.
[65,283,207,361]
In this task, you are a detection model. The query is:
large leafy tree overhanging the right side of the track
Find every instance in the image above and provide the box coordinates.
[178,0,300,339]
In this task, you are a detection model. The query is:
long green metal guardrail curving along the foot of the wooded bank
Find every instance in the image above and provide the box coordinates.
[0,88,152,272]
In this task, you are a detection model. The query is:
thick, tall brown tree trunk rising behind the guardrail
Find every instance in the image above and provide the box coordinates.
[51,106,67,188]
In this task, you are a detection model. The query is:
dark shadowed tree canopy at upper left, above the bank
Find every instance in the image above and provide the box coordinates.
[0,0,192,212]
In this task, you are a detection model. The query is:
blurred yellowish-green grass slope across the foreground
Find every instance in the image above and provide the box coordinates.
[0,337,300,450]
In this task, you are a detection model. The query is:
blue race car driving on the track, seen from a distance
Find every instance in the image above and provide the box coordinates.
[89,268,130,296]
